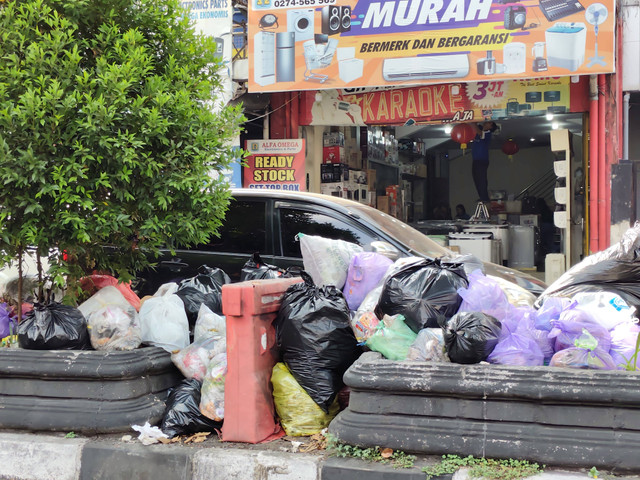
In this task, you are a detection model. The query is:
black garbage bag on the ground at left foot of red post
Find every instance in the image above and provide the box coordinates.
[160,378,222,438]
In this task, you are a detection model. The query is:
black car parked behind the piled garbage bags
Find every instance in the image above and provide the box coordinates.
[138,189,546,295]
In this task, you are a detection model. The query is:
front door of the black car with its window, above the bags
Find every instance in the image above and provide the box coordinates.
[273,201,381,274]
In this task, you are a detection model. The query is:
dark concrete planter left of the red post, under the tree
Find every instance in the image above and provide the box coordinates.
[0,347,183,433]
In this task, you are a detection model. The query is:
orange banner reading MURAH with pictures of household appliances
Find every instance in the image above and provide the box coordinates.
[248,0,616,92]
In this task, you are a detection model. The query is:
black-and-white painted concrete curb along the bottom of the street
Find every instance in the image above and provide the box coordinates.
[0,431,640,480]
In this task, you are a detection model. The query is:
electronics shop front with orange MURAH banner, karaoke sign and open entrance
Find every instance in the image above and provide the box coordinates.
[245,0,619,272]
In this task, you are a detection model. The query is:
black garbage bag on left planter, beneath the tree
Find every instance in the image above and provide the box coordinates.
[18,302,91,350]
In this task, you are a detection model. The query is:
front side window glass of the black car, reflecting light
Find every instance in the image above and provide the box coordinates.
[278,208,378,257]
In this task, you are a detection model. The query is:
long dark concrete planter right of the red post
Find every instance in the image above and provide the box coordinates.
[329,352,640,471]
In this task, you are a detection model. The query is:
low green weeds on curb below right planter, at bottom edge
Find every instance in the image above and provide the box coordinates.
[422,455,544,480]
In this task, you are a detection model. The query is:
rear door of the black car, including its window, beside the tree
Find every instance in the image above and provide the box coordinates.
[139,198,273,294]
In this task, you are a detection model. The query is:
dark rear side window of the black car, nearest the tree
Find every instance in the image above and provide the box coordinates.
[203,200,267,253]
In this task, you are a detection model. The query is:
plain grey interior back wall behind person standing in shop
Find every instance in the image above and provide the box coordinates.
[449,146,554,213]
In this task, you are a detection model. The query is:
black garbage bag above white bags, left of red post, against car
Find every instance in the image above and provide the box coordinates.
[176,265,231,327]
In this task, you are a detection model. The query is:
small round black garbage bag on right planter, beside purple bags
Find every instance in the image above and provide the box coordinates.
[440,312,502,363]
